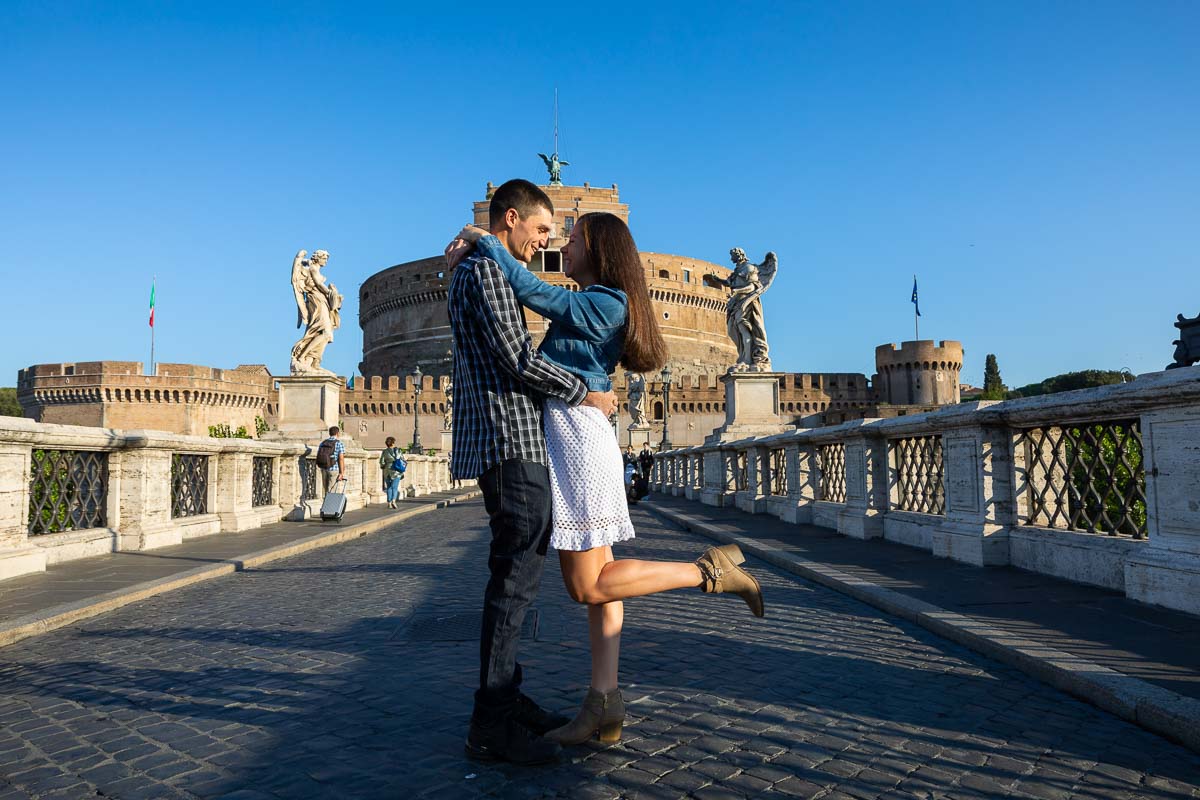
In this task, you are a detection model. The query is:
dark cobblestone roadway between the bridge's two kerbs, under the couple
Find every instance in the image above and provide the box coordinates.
[0,501,1200,800]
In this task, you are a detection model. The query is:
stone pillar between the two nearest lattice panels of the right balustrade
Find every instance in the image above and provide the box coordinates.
[931,425,1016,566]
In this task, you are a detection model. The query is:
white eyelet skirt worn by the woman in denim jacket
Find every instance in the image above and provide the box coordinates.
[542,399,634,551]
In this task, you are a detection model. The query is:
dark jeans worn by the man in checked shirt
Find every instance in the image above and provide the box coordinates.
[474,459,551,724]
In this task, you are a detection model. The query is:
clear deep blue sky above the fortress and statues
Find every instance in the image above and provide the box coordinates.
[0,0,1200,386]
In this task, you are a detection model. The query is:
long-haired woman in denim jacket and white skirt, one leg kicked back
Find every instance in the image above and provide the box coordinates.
[446,213,763,744]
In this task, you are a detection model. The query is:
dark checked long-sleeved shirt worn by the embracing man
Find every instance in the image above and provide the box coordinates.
[449,253,587,480]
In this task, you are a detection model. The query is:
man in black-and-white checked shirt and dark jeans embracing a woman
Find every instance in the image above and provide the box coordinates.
[448,180,617,764]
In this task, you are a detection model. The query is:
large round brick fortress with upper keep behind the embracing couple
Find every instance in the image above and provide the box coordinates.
[359,184,737,377]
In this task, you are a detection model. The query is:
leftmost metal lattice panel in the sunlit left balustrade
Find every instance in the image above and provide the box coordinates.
[29,450,108,536]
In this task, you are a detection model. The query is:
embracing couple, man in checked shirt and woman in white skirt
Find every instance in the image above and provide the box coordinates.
[446,180,763,764]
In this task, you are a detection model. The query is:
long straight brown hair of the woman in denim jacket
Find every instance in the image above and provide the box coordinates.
[577,212,667,372]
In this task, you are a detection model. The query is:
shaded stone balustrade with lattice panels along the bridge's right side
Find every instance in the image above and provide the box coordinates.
[652,367,1200,614]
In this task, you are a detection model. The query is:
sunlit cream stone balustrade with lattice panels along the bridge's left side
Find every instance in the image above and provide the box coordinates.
[0,417,454,579]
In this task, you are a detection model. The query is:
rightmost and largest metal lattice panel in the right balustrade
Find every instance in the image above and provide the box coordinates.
[1016,420,1147,539]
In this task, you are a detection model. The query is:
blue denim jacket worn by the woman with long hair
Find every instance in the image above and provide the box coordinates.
[475,236,629,392]
